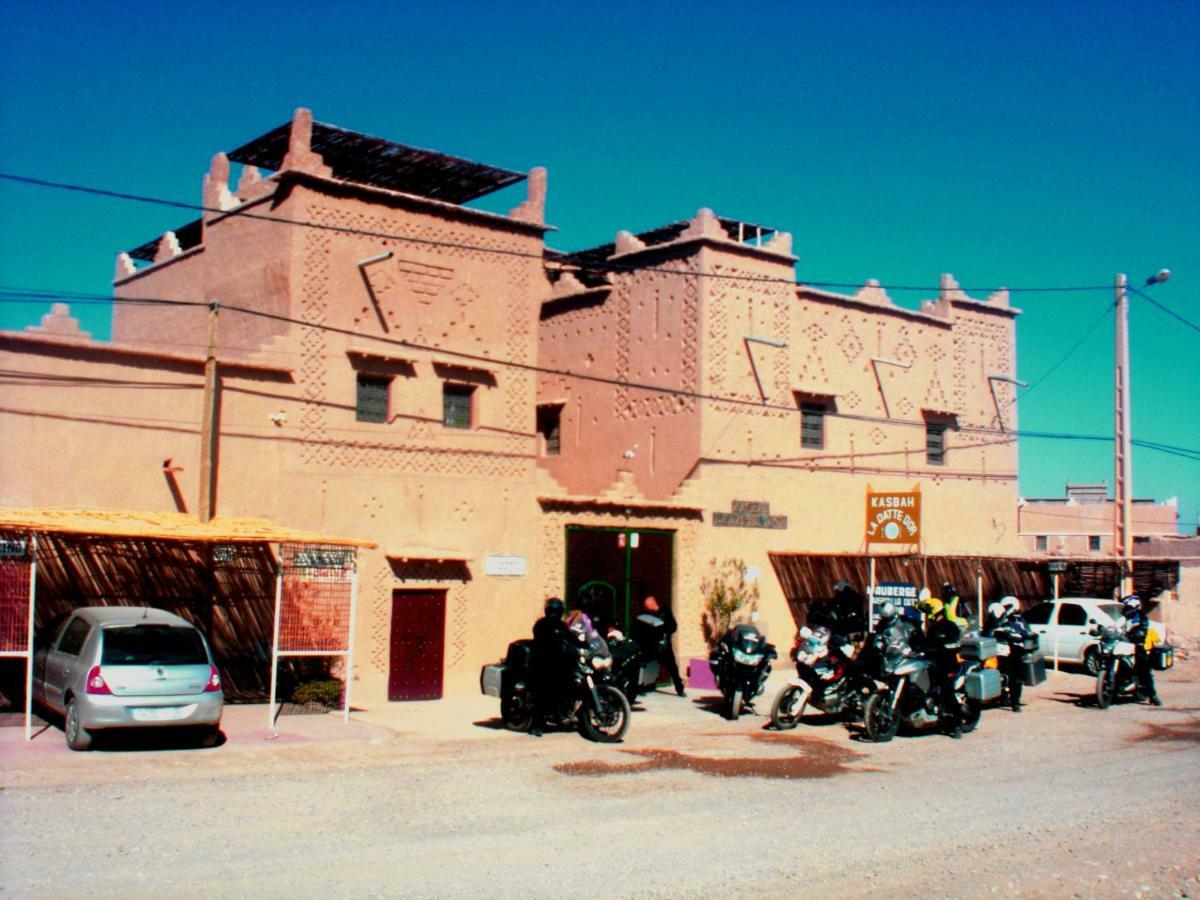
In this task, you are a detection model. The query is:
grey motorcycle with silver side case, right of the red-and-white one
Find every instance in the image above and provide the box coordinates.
[863,638,984,744]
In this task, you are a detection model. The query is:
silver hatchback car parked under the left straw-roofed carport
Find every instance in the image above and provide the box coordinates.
[34,606,224,750]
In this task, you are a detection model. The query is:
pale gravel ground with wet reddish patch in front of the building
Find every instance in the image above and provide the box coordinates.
[0,661,1200,898]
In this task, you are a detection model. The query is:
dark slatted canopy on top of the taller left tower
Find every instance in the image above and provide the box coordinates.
[229,121,526,204]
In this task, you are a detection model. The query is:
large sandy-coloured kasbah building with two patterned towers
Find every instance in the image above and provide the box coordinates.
[7,109,1104,707]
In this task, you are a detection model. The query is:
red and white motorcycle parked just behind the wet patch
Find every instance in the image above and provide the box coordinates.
[770,628,875,731]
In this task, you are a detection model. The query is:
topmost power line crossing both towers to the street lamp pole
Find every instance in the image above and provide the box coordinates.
[0,172,1111,294]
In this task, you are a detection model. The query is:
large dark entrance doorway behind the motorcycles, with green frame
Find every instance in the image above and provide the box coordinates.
[563,526,674,632]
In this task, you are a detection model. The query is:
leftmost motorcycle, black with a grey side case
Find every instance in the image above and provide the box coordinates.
[479,631,630,743]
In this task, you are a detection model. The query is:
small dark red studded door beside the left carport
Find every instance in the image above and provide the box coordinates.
[388,590,446,700]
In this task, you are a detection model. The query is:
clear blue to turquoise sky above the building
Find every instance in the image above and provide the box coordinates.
[0,0,1200,530]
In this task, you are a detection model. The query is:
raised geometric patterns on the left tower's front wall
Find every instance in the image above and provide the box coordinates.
[299,203,540,478]
